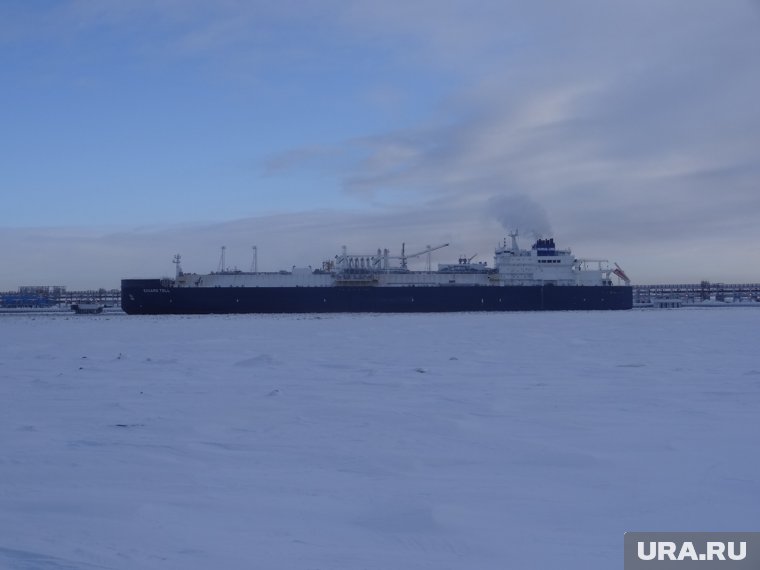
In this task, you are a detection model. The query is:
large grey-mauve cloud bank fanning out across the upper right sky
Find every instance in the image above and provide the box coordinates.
[258,3,760,251]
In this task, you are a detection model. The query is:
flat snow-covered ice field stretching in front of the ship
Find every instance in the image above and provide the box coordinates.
[0,308,760,570]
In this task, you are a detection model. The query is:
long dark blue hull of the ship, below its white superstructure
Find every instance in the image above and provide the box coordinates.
[121,279,633,315]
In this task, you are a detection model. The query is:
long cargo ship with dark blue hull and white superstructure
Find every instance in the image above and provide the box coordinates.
[121,232,633,315]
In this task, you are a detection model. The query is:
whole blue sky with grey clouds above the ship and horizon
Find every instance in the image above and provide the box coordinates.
[0,0,760,290]
